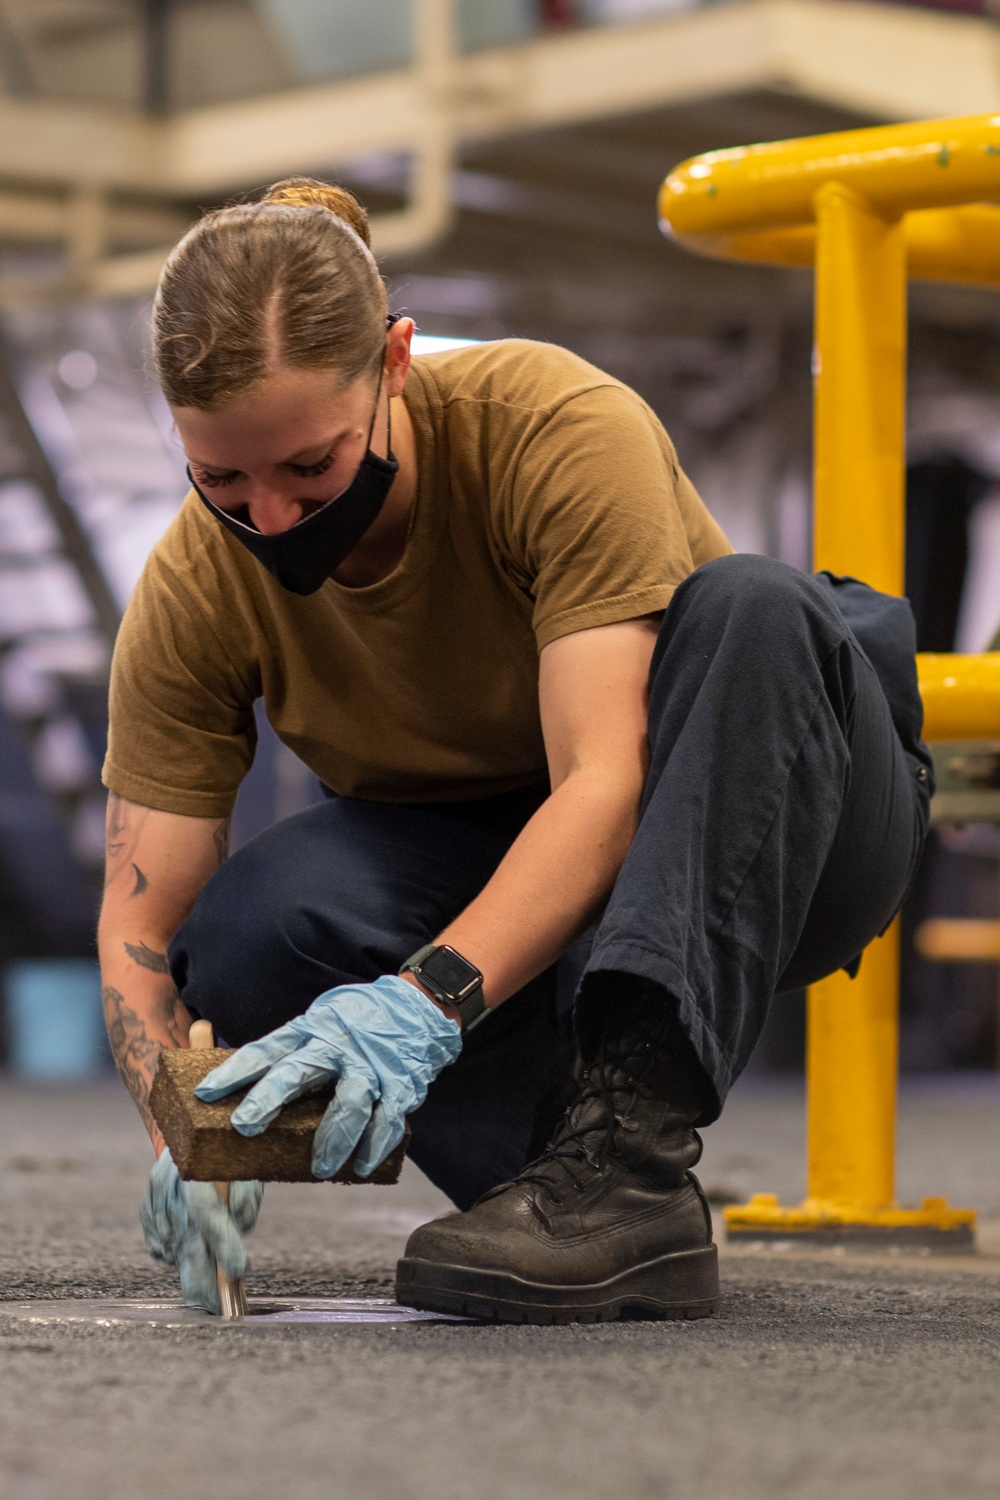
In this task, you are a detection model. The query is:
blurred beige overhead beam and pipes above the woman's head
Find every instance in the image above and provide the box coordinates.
[0,0,1000,302]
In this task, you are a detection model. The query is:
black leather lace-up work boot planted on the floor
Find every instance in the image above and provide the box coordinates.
[396,1028,718,1323]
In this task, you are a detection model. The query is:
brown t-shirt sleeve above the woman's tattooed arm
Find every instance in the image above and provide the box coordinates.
[103,554,259,818]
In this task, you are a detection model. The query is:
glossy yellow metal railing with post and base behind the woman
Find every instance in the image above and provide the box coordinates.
[660,116,1000,1245]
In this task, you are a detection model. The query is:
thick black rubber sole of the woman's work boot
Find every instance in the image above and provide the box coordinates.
[396,1245,718,1323]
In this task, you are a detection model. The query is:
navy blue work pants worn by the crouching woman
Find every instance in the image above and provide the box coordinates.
[169,557,930,1208]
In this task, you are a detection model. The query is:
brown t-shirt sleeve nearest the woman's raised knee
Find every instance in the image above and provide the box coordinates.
[504,386,729,650]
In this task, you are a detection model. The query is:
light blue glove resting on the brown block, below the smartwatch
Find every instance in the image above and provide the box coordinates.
[195,975,462,1178]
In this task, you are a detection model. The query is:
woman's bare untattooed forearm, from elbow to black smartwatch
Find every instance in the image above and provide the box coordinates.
[438,770,640,1007]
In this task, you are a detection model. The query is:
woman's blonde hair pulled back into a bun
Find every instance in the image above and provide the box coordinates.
[153,177,385,411]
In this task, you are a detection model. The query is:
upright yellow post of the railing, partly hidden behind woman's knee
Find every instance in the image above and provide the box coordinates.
[807,183,907,1214]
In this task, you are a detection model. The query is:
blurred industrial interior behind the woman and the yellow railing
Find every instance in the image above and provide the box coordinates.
[0,0,1000,1077]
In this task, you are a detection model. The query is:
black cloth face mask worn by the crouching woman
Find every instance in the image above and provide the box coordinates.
[187,378,399,594]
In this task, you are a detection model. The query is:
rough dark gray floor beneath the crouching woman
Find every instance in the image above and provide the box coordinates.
[0,1079,1000,1500]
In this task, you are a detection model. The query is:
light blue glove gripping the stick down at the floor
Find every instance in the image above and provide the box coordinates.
[139,1151,264,1313]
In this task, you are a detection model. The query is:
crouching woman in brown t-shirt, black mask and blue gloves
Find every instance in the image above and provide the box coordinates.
[100,179,928,1322]
